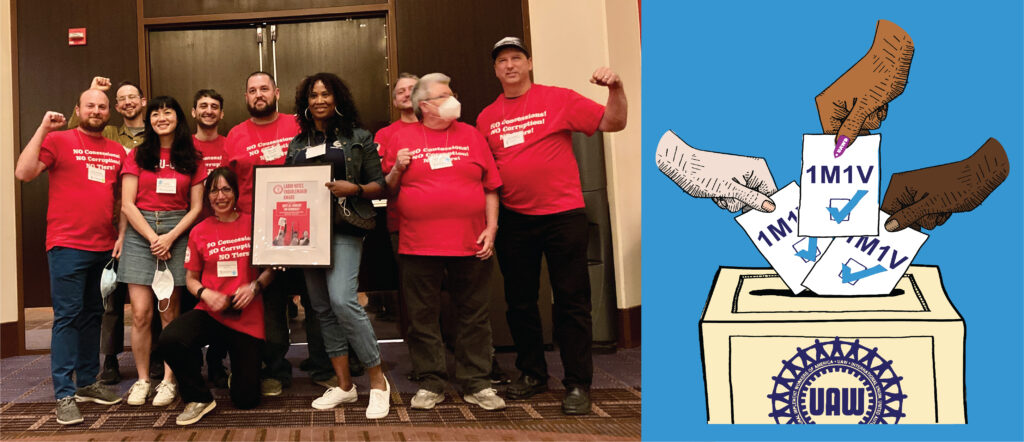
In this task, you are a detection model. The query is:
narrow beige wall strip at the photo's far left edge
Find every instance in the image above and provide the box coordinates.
[0,0,19,322]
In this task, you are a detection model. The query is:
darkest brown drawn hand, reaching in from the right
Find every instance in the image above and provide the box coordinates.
[882,138,1010,231]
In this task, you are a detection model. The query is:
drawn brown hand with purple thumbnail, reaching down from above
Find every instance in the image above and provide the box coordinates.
[814,19,913,158]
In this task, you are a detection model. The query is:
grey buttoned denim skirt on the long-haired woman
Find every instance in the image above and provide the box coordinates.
[118,210,190,285]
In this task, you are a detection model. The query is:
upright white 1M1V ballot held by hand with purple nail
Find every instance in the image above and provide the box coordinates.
[797,135,882,236]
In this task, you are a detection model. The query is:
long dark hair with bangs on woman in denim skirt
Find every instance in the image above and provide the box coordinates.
[135,95,200,175]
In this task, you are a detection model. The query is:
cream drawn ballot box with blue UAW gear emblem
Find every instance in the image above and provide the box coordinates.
[699,265,967,424]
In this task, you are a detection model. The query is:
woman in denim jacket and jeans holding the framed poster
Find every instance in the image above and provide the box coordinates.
[282,73,391,418]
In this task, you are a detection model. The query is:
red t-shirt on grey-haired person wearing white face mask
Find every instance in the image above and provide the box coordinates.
[384,122,502,256]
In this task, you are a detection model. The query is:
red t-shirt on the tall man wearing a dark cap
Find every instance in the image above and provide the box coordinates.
[476,84,604,215]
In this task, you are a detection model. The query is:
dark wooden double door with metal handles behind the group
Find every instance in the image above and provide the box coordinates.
[147,15,391,135]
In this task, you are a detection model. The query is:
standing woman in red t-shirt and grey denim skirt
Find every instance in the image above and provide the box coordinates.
[118,96,206,406]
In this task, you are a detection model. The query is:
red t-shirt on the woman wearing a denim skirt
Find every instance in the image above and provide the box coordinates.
[121,148,206,212]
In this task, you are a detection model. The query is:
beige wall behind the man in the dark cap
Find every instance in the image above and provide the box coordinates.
[529,0,641,309]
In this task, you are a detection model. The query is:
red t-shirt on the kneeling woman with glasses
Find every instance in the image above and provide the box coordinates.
[185,214,264,339]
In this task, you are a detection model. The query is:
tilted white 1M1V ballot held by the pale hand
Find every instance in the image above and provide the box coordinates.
[736,182,833,294]
